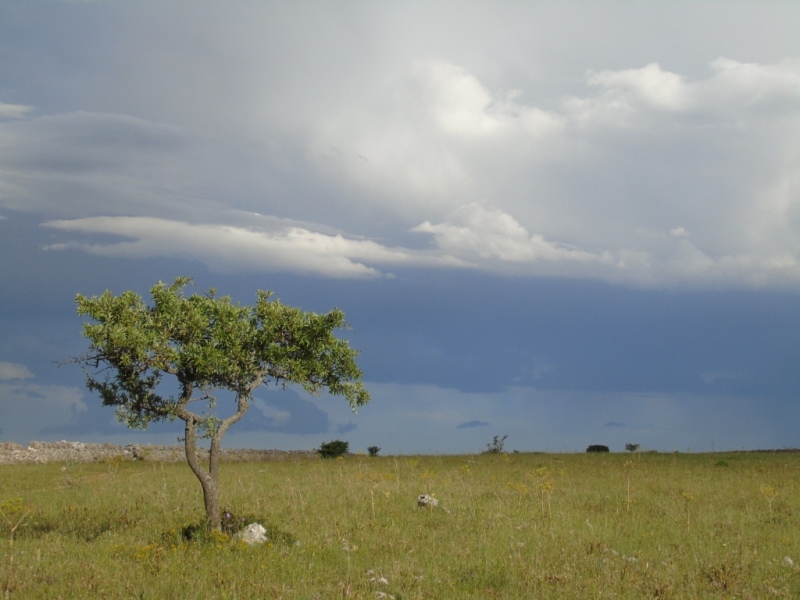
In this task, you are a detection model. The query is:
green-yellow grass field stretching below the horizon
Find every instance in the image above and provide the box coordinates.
[0,453,800,600]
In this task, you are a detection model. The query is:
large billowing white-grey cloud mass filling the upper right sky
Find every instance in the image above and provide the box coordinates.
[304,59,800,285]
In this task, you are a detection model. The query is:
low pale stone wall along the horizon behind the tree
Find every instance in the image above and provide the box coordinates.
[0,441,319,464]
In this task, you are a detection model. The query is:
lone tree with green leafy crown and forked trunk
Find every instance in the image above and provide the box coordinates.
[74,277,369,529]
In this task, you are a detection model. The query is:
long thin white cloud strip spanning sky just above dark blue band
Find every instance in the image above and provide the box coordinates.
[36,198,800,288]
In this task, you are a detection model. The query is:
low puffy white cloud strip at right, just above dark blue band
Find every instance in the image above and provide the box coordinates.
[412,204,800,288]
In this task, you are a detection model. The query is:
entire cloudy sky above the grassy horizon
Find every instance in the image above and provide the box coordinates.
[0,0,800,454]
